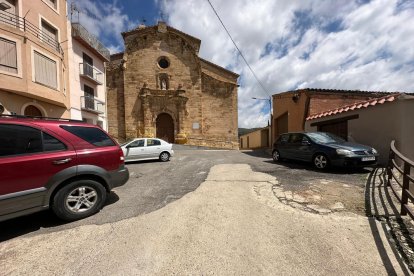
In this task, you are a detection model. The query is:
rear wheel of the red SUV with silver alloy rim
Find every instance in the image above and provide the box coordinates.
[52,179,106,221]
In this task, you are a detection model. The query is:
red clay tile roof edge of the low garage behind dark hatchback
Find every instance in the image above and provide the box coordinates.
[306,93,401,121]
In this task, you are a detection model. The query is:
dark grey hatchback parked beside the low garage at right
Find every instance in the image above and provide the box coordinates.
[272,132,378,169]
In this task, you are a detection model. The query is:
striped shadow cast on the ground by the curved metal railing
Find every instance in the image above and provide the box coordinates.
[365,168,414,275]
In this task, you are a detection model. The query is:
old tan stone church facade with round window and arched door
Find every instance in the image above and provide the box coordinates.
[106,22,239,149]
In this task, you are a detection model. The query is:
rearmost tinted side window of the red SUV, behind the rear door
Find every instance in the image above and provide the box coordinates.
[60,126,115,147]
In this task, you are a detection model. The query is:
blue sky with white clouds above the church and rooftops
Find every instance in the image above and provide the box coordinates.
[69,0,414,127]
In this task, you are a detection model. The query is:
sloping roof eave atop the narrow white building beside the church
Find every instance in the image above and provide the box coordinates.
[72,23,110,61]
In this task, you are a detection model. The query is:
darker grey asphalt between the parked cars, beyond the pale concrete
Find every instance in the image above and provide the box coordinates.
[0,145,367,241]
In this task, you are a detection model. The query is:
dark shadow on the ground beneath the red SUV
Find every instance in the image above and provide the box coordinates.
[0,191,119,242]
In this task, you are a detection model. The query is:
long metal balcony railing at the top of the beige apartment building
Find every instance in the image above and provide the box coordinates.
[0,10,63,55]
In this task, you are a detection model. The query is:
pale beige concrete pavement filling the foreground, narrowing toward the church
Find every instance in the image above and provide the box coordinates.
[0,163,409,276]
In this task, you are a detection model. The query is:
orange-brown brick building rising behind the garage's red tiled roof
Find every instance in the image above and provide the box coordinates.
[272,88,389,141]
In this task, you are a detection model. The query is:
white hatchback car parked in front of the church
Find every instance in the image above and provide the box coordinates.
[121,138,174,162]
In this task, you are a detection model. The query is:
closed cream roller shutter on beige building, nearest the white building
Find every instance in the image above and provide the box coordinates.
[34,51,57,89]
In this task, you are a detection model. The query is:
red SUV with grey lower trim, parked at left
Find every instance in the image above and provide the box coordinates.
[0,115,129,221]
